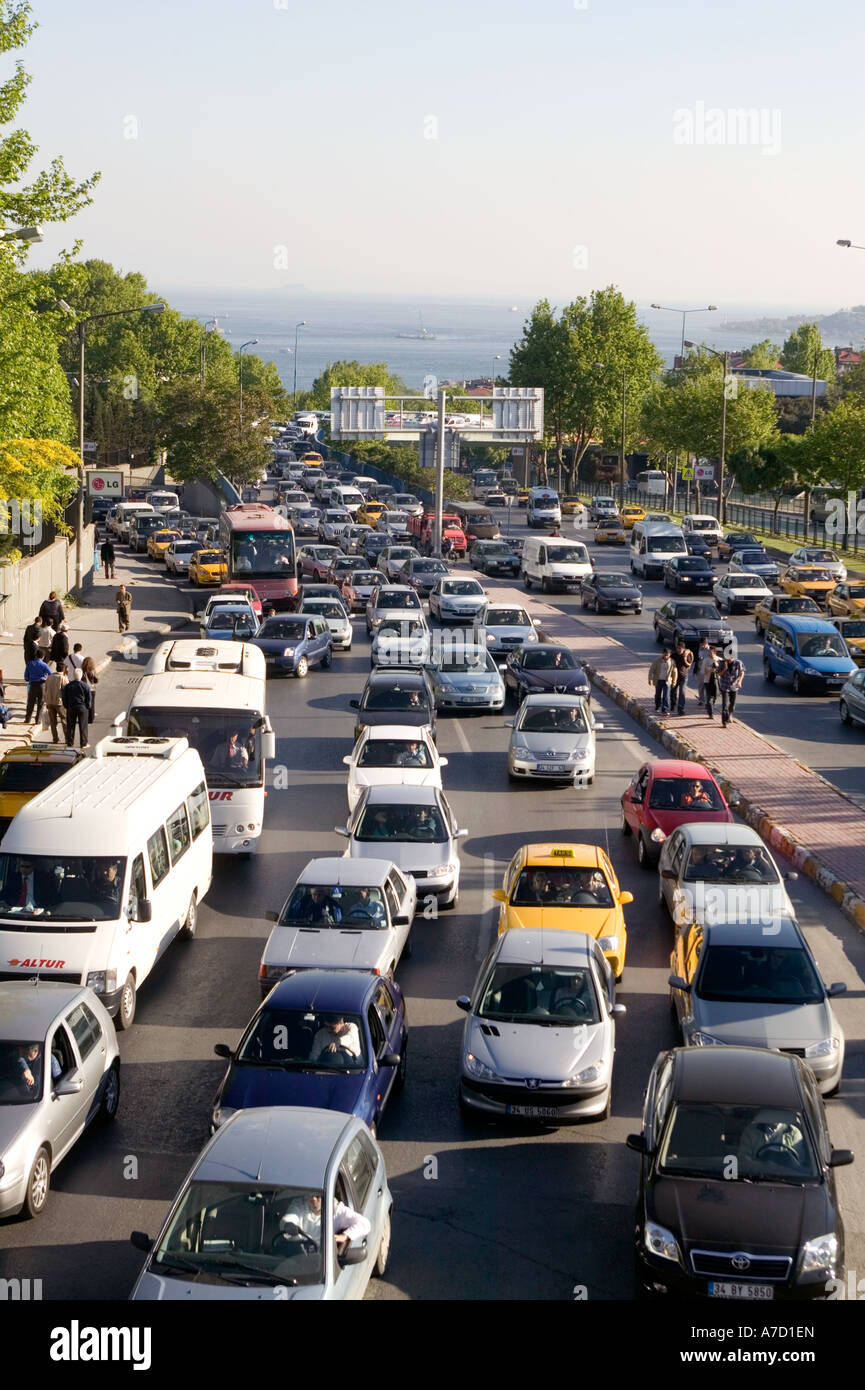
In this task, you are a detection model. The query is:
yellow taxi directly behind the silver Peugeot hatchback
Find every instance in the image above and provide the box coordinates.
[492,844,634,980]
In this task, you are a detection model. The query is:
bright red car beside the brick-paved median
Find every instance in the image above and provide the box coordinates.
[622,758,733,869]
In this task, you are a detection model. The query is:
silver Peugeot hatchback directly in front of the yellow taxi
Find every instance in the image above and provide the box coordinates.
[456,929,626,1125]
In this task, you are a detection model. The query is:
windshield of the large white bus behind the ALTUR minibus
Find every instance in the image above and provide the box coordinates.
[128,706,263,805]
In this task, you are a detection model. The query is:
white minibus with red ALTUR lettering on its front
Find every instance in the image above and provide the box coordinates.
[0,737,213,1029]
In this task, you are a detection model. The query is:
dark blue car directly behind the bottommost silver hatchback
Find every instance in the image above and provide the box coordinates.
[210,970,409,1134]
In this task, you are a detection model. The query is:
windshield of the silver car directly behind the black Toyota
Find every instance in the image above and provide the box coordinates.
[698,944,823,1004]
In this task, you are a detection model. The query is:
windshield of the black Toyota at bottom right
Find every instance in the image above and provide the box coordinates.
[658,1101,819,1183]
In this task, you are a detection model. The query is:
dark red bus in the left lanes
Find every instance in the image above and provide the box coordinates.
[220,502,298,612]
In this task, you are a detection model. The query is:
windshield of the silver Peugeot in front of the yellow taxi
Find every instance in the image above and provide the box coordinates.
[477,965,601,1029]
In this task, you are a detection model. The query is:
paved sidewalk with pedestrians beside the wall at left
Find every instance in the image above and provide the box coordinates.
[0,546,189,756]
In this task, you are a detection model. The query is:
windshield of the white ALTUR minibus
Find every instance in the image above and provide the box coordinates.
[0,853,127,928]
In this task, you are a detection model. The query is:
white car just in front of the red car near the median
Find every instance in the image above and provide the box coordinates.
[658,821,798,929]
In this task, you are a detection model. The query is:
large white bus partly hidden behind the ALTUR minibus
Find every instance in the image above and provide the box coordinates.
[122,639,277,858]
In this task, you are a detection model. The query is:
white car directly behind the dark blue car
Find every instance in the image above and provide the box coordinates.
[259,855,417,994]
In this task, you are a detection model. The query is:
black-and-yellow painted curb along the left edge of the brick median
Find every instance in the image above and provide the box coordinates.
[583,662,865,931]
